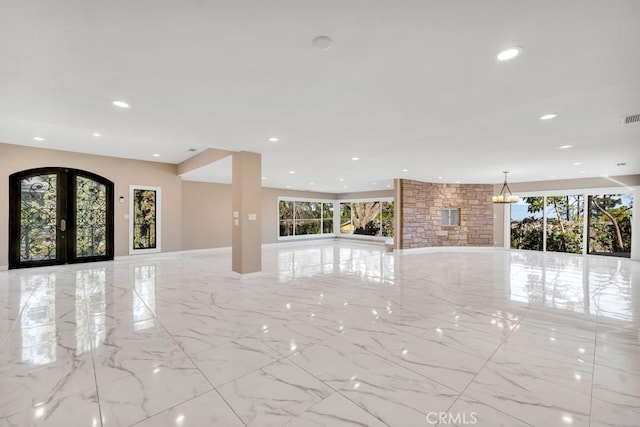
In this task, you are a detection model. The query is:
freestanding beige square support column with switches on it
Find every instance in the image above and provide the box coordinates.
[231,151,262,274]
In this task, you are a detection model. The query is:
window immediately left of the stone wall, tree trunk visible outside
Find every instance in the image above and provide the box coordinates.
[340,200,393,237]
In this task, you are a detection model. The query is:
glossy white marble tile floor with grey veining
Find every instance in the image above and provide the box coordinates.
[0,240,640,427]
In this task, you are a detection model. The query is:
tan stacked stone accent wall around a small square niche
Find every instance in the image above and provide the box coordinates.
[396,179,493,249]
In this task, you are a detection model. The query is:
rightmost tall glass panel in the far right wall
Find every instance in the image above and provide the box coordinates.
[588,194,633,258]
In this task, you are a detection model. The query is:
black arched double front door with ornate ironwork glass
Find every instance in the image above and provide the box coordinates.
[9,168,113,268]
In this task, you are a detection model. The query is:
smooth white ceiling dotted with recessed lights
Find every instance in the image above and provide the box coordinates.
[0,0,640,193]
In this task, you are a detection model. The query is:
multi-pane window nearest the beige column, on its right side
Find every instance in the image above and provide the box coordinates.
[278,200,333,237]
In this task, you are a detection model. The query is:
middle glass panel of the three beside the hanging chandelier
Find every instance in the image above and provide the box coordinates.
[545,196,584,254]
